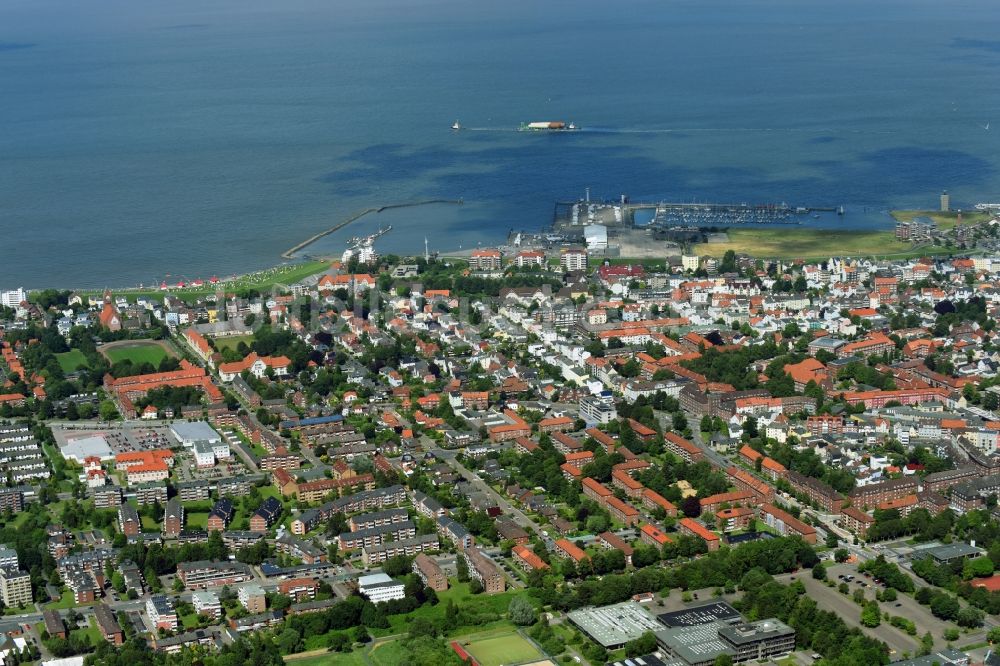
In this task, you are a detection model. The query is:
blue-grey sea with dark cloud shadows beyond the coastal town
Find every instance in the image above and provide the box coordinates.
[0,0,1000,287]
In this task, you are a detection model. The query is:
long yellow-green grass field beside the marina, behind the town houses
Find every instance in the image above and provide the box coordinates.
[692,227,916,259]
